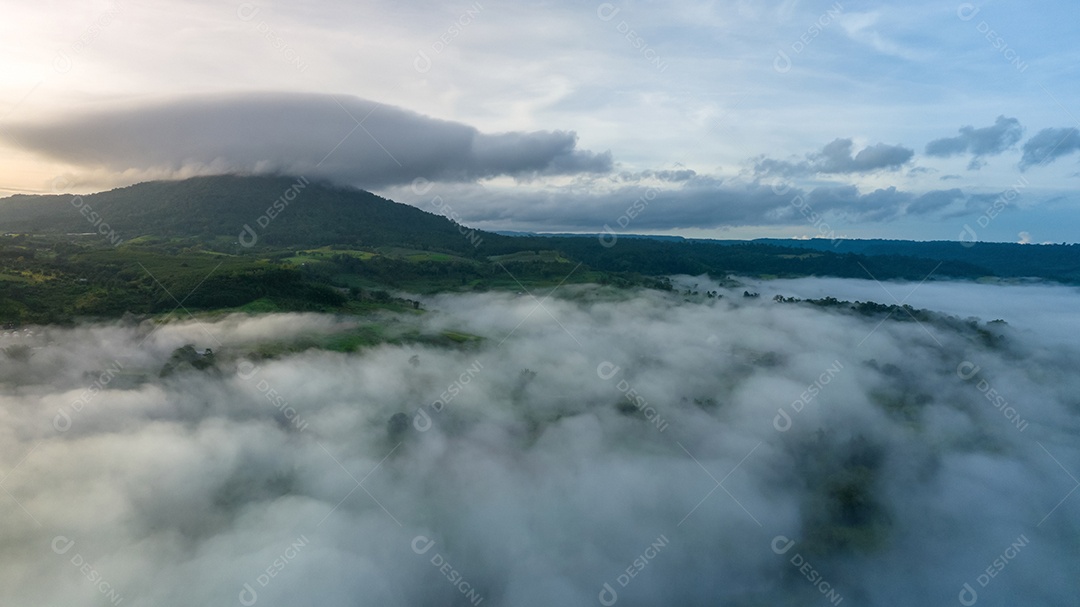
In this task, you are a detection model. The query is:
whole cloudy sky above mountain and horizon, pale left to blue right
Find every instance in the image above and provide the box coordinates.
[0,0,1080,243]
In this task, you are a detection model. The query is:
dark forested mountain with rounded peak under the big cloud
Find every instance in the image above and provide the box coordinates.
[0,175,499,254]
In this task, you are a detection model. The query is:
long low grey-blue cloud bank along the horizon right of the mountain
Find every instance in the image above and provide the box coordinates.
[388,172,964,232]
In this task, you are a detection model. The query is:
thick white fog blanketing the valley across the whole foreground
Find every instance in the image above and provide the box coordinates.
[0,278,1080,607]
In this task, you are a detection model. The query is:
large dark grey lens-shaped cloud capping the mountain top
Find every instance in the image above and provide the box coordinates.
[0,93,612,188]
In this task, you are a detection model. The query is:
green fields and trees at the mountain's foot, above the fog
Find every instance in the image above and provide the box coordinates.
[0,234,649,324]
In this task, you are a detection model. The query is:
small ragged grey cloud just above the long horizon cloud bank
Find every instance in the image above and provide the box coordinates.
[754,139,915,177]
